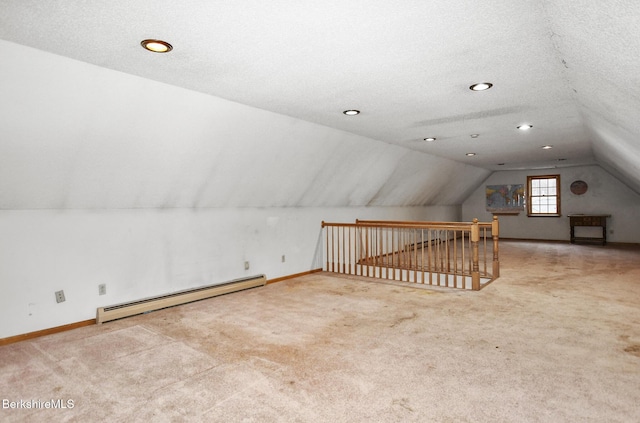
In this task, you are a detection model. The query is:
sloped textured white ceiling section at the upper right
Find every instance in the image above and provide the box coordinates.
[544,1,640,193]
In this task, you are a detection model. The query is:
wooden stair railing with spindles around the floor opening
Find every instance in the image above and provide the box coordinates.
[322,216,500,290]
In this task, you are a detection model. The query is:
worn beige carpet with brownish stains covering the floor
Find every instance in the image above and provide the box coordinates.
[0,241,640,423]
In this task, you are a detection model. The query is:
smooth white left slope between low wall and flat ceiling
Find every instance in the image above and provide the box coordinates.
[0,41,488,209]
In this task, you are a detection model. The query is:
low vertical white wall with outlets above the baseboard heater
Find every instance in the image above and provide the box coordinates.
[0,206,460,338]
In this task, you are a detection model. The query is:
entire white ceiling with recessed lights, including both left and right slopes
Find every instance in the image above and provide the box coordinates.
[0,0,640,208]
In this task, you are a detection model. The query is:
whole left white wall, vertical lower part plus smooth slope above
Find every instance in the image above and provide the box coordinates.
[0,40,480,338]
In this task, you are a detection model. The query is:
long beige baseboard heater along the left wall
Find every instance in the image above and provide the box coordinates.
[96,275,267,324]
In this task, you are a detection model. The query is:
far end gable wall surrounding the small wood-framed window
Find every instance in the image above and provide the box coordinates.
[462,166,640,243]
